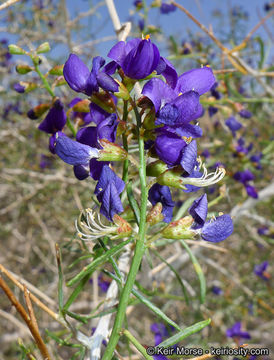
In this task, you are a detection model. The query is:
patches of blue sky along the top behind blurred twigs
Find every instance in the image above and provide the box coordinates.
[67,0,271,56]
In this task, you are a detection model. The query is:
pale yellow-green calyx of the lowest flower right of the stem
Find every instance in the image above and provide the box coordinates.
[161,216,196,239]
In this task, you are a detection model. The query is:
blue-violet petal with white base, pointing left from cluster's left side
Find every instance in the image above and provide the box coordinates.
[55,136,98,165]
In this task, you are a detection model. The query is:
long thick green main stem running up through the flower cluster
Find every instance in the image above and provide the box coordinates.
[102,102,148,360]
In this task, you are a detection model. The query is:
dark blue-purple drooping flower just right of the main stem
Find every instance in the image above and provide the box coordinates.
[148,184,175,223]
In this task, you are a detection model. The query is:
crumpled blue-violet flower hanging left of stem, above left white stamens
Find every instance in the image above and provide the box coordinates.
[94,165,125,221]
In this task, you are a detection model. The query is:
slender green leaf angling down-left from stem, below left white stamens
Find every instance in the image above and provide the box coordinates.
[67,238,132,286]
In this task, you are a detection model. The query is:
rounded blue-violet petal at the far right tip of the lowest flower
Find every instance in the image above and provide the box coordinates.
[201,215,233,243]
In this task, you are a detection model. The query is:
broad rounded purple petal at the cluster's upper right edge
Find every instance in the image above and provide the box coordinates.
[176,66,216,95]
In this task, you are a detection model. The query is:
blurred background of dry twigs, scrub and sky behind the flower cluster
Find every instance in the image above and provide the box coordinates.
[0,0,274,360]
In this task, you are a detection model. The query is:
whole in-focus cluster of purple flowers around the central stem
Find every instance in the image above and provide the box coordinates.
[16,35,235,242]
